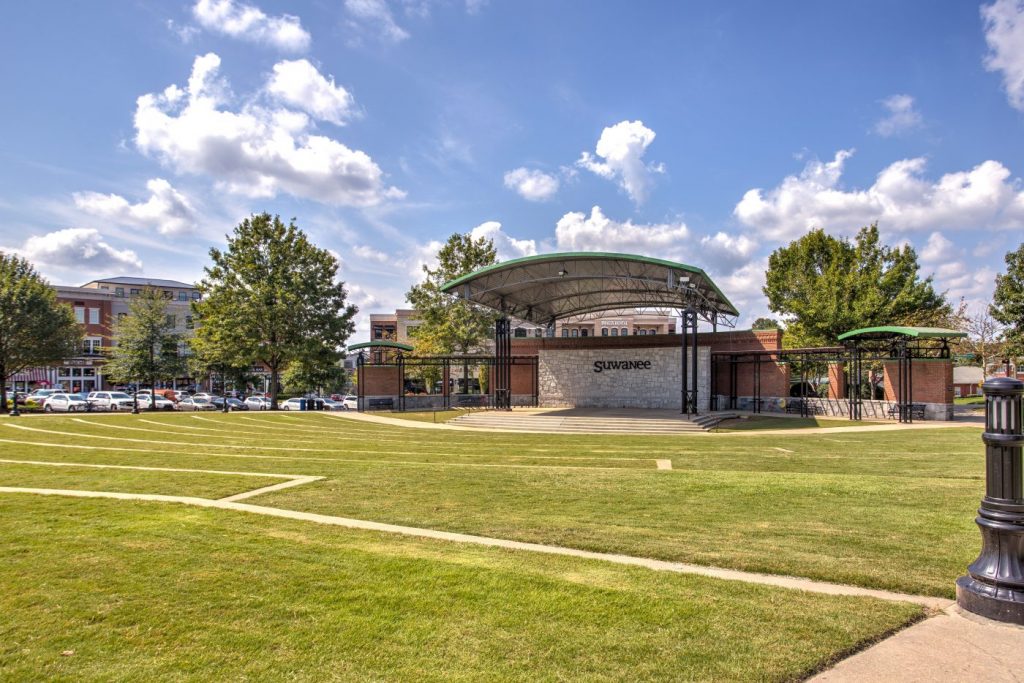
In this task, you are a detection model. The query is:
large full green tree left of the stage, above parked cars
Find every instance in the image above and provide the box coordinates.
[193,213,356,410]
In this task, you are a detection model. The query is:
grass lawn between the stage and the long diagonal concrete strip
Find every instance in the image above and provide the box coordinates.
[0,414,984,597]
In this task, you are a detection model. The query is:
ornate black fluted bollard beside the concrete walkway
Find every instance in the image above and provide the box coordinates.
[956,377,1024,625]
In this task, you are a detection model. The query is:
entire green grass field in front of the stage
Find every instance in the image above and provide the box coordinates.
[0,414,984,680]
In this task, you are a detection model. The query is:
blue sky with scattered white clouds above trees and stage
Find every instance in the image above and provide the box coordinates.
[0,0,1024,333]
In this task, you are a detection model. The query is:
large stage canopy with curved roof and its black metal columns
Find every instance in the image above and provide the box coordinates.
[441,252,739,414]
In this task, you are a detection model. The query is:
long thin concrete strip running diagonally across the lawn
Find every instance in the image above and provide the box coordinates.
[0,486,952,610]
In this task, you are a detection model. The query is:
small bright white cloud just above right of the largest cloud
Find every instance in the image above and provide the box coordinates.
[266,59,355,126]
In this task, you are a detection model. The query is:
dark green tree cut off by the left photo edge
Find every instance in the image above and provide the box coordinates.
[0,252,83,410]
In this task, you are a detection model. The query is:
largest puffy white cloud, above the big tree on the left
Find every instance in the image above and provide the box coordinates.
[135,52,404,207]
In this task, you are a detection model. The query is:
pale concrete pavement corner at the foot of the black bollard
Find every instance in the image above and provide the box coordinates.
[811,605,1024,683]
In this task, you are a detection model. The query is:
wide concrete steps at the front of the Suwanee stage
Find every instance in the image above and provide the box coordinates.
[449,411,734,434]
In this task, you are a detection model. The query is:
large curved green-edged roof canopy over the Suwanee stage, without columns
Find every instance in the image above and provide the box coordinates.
[441,252,739,323]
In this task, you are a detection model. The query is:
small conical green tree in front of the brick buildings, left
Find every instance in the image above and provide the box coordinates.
[105,288,184,411]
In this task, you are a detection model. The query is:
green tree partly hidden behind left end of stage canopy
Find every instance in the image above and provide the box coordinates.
[406,232,498,353]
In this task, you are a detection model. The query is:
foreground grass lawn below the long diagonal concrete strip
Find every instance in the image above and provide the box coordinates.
[0,493,922,681]
